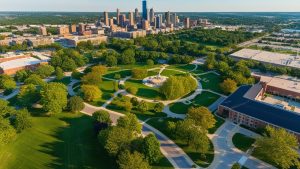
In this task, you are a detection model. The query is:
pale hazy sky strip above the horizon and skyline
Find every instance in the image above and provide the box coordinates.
[0,0,300,12]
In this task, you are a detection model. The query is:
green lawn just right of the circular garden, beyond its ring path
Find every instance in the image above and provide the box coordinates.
[199,73,223,93]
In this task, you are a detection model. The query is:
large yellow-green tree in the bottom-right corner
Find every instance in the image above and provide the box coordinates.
[255,126,300,169]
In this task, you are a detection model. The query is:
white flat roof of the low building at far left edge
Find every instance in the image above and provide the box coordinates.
[0,56,50,70]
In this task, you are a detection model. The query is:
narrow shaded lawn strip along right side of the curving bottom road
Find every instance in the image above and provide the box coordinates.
[147,118,214,167]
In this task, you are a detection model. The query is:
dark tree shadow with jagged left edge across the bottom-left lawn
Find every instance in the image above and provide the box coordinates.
[40,115,116,169]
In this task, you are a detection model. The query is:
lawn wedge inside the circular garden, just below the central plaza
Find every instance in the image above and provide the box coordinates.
[125,79,163,100]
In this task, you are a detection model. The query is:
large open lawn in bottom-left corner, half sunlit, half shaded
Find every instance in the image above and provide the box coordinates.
[0,113,112,169]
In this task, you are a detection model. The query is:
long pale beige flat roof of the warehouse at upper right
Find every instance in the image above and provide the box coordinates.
[231,49,300,68]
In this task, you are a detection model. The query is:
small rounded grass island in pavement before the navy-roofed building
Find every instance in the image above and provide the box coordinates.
[232,133,255,152]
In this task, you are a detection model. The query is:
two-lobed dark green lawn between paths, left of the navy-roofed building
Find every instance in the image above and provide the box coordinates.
[170,91,220,114]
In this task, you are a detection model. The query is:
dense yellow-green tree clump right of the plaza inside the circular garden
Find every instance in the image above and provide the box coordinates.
[160,75,197,100]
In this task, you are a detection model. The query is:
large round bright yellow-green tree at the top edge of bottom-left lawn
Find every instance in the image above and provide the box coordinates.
[40,83,68,113]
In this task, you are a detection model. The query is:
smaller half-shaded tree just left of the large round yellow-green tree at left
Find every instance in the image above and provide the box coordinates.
[17,84,40,107]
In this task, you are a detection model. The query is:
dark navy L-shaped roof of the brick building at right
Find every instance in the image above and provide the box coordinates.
[220,85,300,133]
